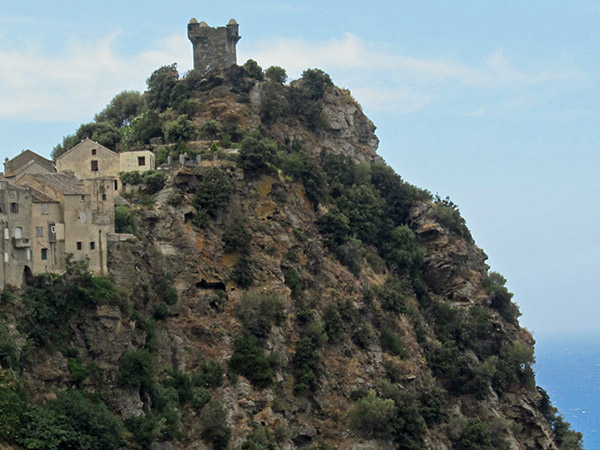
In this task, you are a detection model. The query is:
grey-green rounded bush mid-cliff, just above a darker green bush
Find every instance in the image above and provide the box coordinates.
[235,290,285,338]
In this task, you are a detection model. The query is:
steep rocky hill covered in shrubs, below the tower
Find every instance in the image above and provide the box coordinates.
[0,62,581,450]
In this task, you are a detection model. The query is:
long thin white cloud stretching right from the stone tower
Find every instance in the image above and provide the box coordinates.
[241,33,584,112]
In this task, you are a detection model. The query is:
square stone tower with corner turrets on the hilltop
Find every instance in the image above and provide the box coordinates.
[188,19,240,73]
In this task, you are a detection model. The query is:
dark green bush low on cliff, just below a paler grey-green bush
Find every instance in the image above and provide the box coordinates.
[229,333,277,389]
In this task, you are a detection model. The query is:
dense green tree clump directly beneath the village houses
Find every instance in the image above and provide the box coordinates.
[18,257,127,346]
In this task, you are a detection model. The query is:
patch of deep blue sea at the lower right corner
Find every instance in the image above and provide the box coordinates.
[534,333,600,450]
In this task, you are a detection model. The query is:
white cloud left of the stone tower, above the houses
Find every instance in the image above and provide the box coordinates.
[0,33,191,121]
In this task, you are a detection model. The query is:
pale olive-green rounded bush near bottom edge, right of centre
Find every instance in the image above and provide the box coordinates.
[348,391,396,439]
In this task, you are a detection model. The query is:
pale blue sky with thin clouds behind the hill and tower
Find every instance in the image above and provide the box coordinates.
[0,0,600,338]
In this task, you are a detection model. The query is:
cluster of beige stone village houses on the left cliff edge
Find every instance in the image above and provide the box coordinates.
[0,139,155,288]
